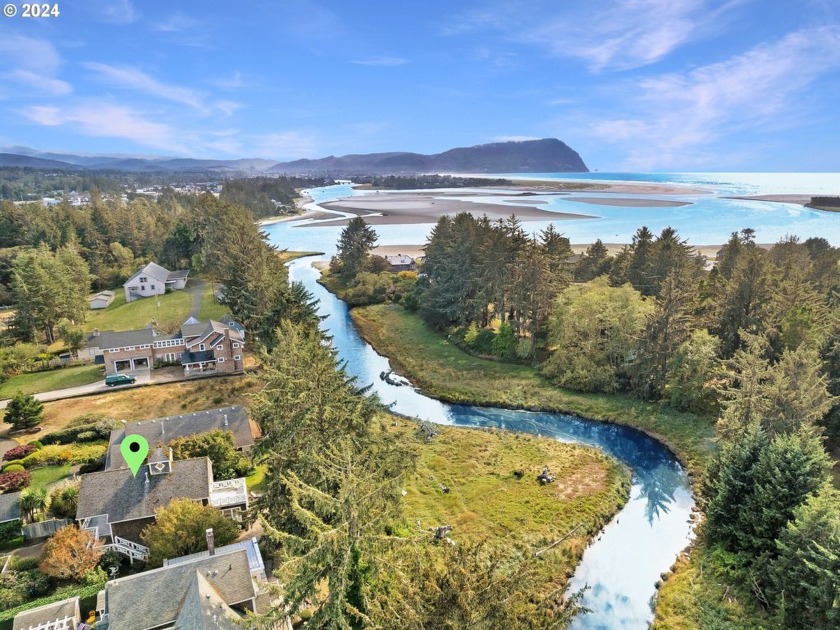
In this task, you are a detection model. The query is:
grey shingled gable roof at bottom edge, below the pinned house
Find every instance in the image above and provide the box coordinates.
[105,550,256,630]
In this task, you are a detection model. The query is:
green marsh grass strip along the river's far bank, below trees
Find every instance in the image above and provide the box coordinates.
[350,305,714,472]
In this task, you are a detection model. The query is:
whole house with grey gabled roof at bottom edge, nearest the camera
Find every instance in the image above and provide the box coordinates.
[96,548,262,630]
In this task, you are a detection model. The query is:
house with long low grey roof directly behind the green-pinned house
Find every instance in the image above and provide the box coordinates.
[105,405,259,470]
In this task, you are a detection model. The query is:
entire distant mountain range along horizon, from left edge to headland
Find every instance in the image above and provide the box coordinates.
[0,138,589,176]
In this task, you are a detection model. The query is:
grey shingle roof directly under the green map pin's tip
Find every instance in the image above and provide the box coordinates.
[76,457,213,523]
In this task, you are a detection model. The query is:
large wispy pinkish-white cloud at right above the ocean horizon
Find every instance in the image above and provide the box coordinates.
[590,27,840,170]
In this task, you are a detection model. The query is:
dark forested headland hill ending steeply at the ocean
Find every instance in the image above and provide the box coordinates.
[270,138,589,175]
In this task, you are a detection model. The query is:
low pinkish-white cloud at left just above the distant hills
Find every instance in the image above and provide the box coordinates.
[21,101,184,152]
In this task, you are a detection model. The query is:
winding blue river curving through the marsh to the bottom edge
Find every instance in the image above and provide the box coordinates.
[289,257,694,629]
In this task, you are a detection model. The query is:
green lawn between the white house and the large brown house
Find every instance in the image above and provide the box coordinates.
[84,290,192,331]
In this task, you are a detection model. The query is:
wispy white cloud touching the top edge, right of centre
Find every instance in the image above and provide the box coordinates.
[444,0,749,72]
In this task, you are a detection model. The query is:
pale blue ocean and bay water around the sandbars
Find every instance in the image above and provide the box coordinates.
[265,173,840,254]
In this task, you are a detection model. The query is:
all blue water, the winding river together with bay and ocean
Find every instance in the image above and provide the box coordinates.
[264,173,840,630]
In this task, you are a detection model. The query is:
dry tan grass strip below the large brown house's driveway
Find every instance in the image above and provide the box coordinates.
[15,375,259,443]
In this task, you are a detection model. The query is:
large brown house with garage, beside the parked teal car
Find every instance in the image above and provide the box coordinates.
[88,315,245,375]
